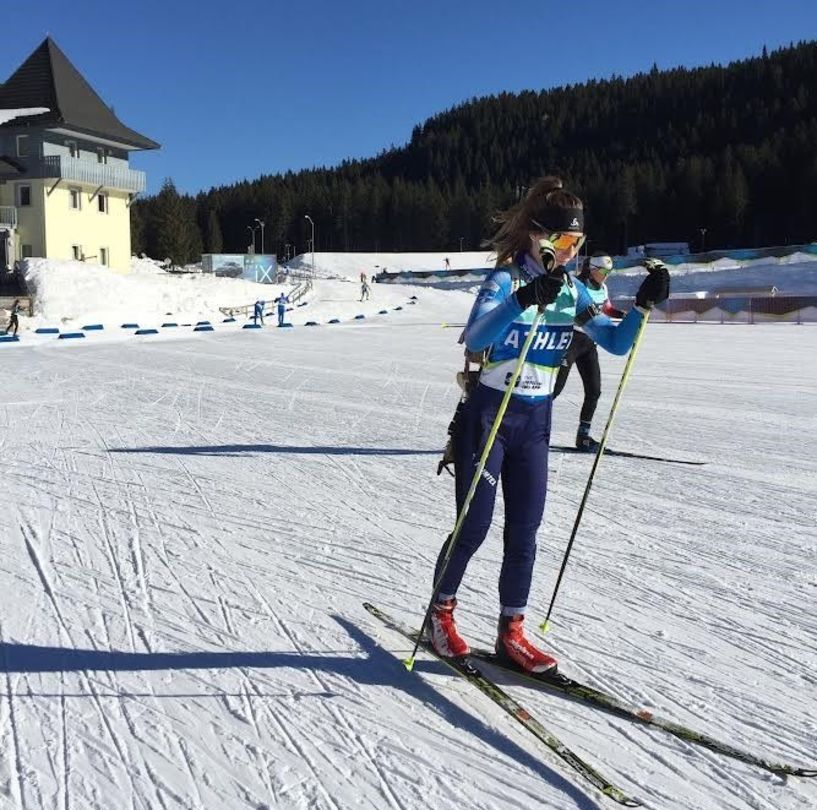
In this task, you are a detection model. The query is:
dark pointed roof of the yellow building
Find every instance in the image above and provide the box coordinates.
[0,37,159,149]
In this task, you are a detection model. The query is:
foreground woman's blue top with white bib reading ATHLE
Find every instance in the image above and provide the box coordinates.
[465,262,644,402]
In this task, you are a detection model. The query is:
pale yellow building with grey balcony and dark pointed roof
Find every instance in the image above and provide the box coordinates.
[0,37,159,272]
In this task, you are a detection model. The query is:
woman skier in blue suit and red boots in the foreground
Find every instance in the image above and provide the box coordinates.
[429,177,669,672]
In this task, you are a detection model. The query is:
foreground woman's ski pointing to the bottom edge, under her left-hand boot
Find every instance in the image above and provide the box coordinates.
[363,602,642,807]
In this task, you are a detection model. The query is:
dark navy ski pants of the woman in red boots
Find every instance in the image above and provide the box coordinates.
[434,385,552,608]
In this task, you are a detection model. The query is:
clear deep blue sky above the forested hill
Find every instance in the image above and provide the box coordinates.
[6,0,817,193]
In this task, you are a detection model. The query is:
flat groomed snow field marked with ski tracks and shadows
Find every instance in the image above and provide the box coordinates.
[0,294,817,810]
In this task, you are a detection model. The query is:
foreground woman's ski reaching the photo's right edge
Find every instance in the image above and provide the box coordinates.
[471,650,817,777]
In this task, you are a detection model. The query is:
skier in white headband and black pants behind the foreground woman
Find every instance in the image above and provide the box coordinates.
[553,253,624,453]
